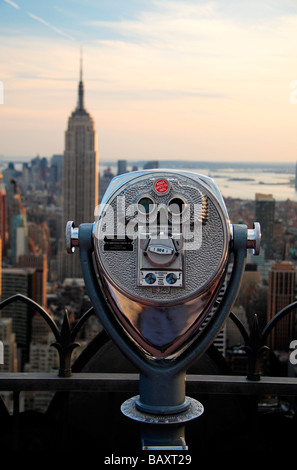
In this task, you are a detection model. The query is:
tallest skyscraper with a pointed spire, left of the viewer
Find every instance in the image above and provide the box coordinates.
[60,60,98,279]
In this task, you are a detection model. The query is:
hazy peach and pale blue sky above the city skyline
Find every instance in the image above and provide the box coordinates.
[0,0,297,162]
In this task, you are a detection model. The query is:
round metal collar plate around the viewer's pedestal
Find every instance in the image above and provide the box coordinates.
[121,395,204,424]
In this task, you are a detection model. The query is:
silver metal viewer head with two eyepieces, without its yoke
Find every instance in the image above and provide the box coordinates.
[94,170,232,360]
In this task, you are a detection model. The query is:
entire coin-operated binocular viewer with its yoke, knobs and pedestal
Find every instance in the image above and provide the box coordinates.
[66,169,261,449]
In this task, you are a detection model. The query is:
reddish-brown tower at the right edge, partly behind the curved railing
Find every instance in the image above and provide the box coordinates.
[267,261,296,350]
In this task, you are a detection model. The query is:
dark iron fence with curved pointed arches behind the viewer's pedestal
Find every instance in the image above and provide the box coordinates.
[0,294,297,453]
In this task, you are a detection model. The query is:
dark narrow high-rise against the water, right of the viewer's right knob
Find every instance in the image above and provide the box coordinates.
[255,193,275,260]
